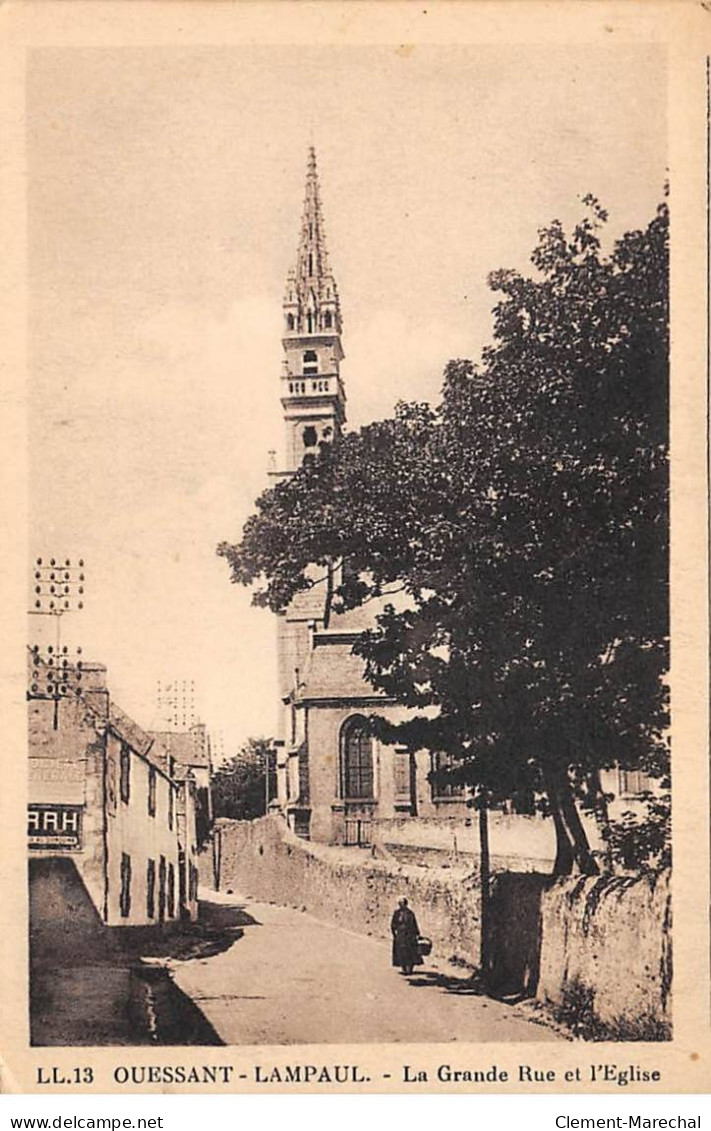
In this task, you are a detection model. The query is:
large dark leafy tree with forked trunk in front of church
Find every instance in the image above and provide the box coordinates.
[218,197,668,872]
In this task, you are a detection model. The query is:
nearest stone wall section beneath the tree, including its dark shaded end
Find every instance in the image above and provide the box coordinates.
[486,874,671,1041]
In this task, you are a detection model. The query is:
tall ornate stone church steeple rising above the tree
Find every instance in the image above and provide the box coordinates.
[276,146,346,478]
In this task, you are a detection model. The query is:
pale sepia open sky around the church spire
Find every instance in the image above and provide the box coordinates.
[27,45,667,754]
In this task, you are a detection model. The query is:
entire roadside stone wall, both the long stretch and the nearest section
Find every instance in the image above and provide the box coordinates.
[216,817,671,1039]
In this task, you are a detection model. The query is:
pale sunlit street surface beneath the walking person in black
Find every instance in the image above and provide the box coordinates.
[171,896,563,1045]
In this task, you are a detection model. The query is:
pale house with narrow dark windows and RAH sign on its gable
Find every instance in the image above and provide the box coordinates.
[27,654,198,926]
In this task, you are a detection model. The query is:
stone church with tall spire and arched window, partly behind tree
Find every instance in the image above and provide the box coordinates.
[271,148,470,845]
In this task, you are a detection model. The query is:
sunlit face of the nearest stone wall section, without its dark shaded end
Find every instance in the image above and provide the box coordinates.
[537,873,671,1041]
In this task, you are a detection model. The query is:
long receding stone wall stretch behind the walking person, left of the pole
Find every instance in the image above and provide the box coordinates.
[216,817,480,965]
